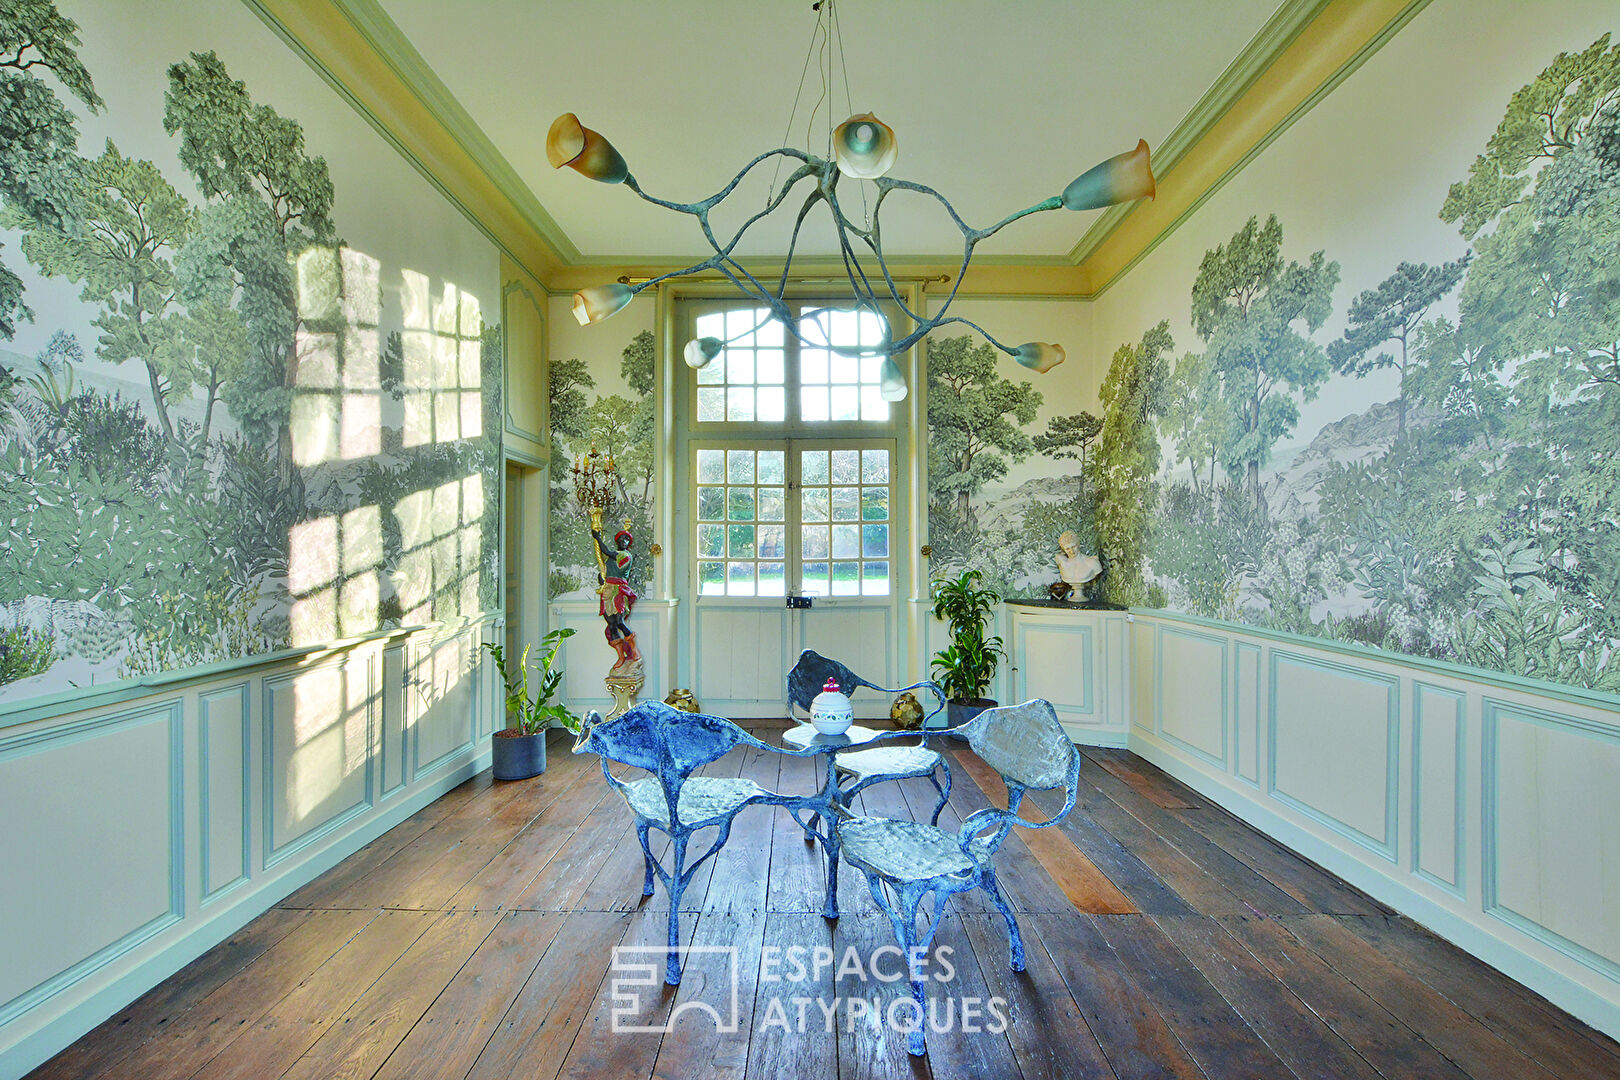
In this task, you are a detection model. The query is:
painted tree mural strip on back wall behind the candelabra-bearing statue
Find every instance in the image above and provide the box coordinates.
[548,330,658,599]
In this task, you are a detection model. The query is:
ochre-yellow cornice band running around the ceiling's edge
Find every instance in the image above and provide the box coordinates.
[243,0,1427,298]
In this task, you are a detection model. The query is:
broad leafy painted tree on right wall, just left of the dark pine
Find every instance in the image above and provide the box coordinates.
[1192,214,1338,508]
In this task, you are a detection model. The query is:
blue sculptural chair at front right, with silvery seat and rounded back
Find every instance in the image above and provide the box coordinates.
[838,698,1081,1054]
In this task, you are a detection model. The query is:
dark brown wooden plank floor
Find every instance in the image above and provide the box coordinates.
[34,722,1620,1080]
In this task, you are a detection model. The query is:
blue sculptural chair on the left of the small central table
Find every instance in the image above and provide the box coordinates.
[573,701,782,986]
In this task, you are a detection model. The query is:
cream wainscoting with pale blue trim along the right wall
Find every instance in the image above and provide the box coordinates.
[1075,606,1620,1036]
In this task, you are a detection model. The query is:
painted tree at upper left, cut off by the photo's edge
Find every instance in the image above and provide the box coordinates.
[0,0,104,340]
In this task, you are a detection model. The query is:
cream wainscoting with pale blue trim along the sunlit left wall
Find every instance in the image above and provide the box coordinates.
[0,614,501,1078]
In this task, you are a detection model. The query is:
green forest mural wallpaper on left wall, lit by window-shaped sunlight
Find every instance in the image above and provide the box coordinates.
[0,0,501,699]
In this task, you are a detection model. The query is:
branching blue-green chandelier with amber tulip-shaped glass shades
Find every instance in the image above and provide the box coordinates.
[546,0,1155,402]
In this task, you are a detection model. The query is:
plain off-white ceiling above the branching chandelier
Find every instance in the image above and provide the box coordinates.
[381,0,1277,261]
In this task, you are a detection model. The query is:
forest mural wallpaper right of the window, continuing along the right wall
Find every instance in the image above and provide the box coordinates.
[928,34,1620,693]
